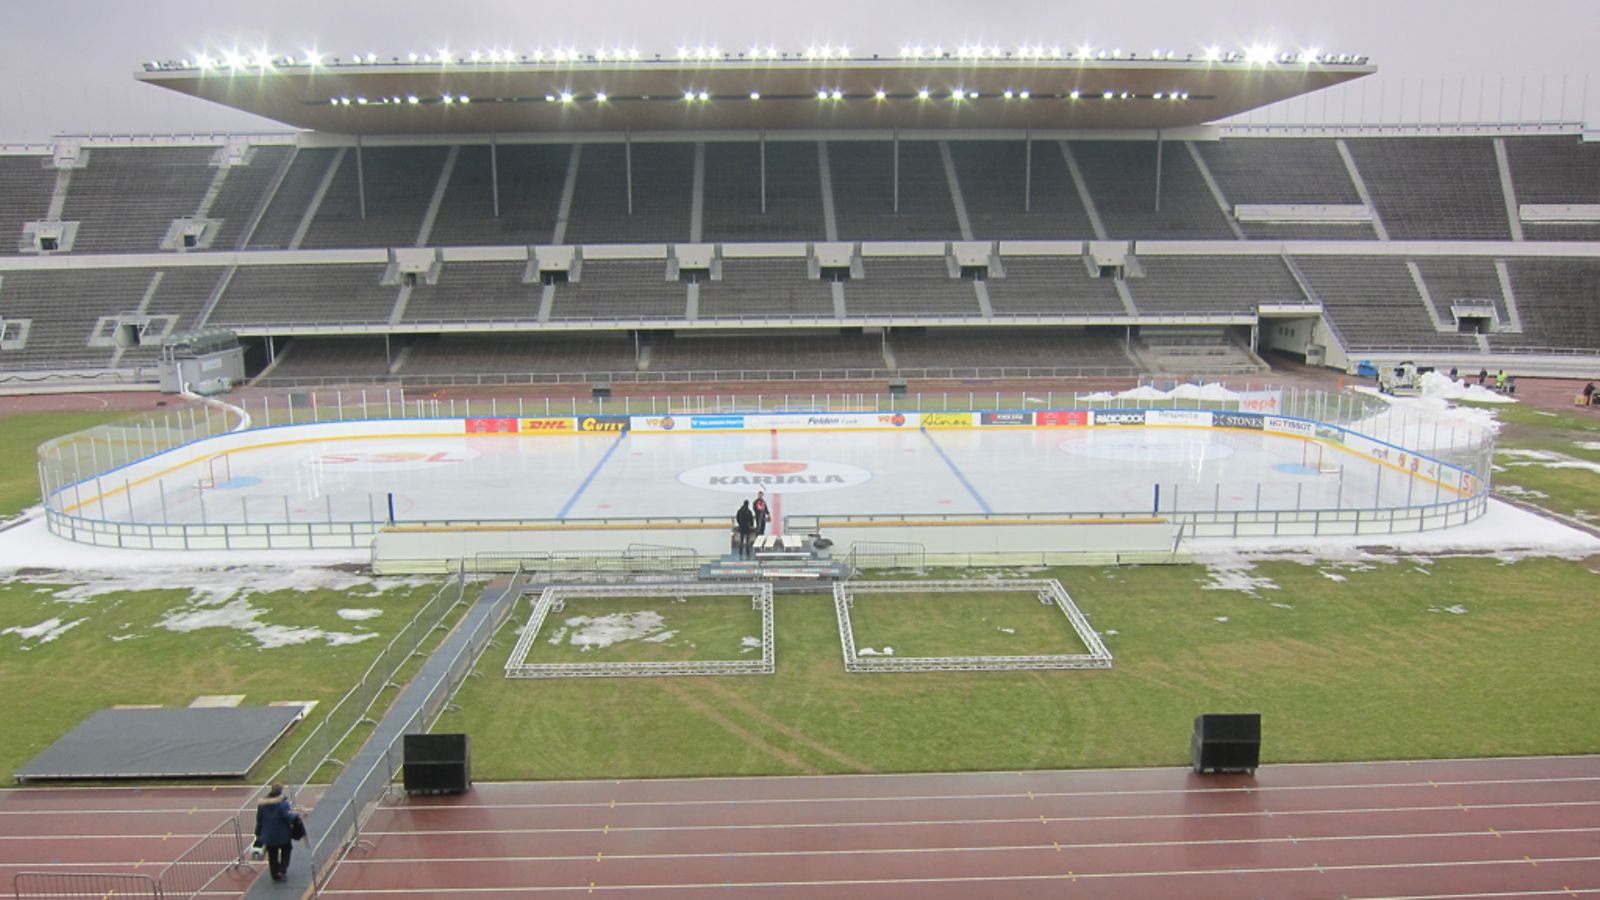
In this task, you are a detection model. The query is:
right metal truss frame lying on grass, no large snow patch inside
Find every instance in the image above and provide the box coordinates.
[834,578,1112,673]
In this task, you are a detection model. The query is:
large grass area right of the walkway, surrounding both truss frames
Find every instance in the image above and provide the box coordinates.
[438,559,1600,780]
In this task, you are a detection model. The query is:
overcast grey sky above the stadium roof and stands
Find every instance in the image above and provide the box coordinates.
[0,0,1600,143]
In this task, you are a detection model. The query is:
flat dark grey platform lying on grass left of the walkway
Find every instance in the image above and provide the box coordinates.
[16,706,301,781]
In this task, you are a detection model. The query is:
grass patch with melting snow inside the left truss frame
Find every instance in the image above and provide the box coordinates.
[523,596,762,665]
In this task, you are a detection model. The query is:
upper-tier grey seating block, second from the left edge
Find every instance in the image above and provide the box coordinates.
[61,147,216,253]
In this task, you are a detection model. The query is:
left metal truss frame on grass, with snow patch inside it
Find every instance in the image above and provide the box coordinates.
[506,583,778,677]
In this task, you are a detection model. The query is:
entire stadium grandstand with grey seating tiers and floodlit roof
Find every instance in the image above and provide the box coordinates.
[0,48,1600,384]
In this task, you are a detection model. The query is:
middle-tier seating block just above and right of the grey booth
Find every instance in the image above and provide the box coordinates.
[208,264,398,327]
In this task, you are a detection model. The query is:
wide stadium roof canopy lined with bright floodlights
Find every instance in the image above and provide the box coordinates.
[136,48,1376,135]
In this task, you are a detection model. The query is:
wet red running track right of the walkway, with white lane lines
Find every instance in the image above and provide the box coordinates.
[308,756,1600,900]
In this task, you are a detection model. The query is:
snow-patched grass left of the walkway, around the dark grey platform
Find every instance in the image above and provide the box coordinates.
[0,580,438,777]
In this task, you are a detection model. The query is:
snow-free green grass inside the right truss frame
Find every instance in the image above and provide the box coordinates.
[850,583,1088,657]
